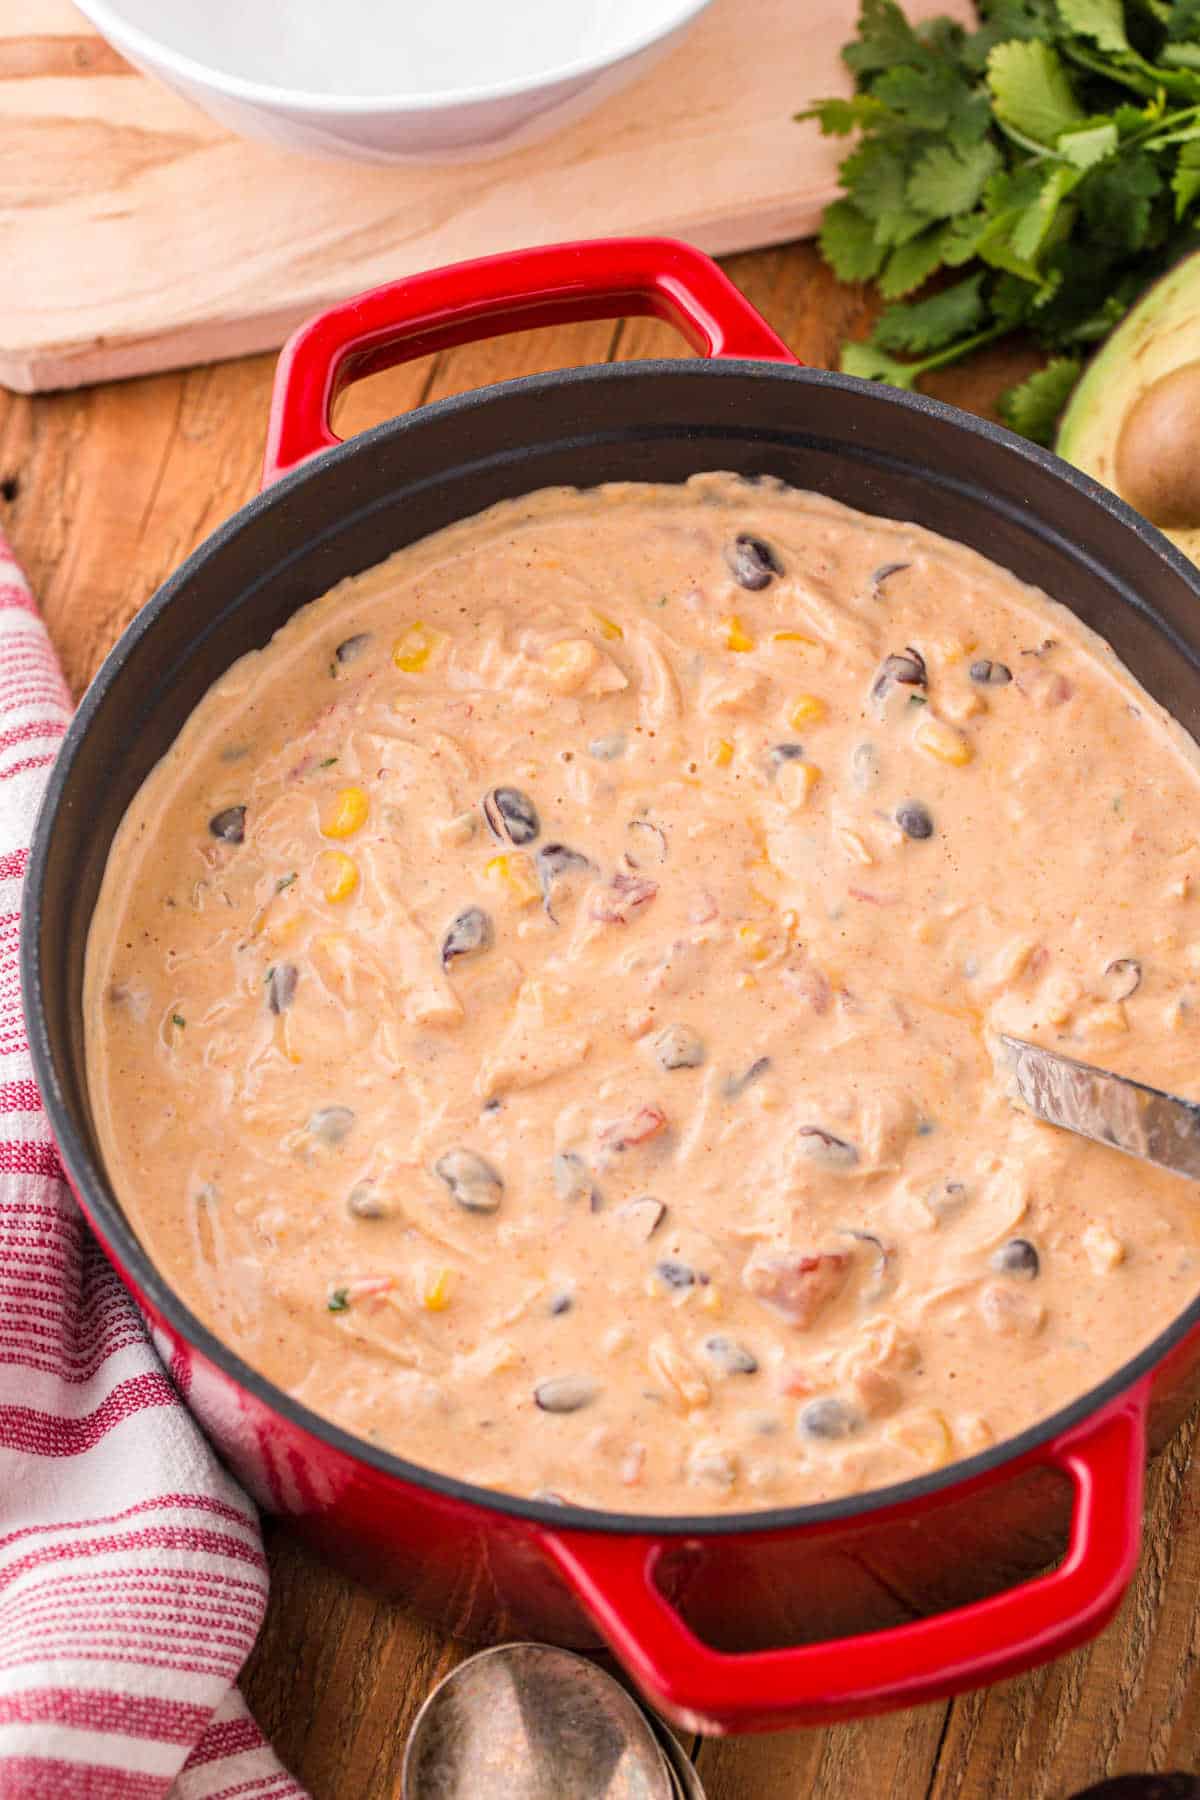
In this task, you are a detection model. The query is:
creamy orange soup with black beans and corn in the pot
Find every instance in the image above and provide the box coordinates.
[86,475,1200,1512]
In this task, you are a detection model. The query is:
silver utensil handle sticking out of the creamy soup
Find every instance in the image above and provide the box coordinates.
[999,1037,1200,1181]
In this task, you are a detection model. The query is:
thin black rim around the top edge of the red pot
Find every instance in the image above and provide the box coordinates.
[20,358,1200,1539]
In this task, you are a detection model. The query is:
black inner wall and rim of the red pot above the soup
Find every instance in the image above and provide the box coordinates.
[23,362,1200,1528]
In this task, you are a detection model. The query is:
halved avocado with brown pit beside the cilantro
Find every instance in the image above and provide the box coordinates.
[1054,250,1200,563]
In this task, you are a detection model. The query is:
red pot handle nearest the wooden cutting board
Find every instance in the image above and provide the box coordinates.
[263,238,795,488]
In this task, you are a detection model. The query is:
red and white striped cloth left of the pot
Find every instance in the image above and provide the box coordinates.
[0,536,304,1800]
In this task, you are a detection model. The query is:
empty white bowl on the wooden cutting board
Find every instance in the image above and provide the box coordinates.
[77,0,711,162]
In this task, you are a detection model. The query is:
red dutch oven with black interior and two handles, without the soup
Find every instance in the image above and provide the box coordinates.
[22,239,1200,1732]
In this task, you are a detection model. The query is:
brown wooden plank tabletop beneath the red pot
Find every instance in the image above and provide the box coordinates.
[0,245,1200,1800]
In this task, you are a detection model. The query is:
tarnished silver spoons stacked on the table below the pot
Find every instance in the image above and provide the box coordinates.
[401,1643,703,1800]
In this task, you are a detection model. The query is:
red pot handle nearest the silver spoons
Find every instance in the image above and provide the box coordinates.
[543,1381,1150,1732]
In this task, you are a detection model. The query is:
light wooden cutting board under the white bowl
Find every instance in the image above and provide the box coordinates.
[0,0,966,392]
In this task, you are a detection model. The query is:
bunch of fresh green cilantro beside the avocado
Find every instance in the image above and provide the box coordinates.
[797,0,1200,443]
